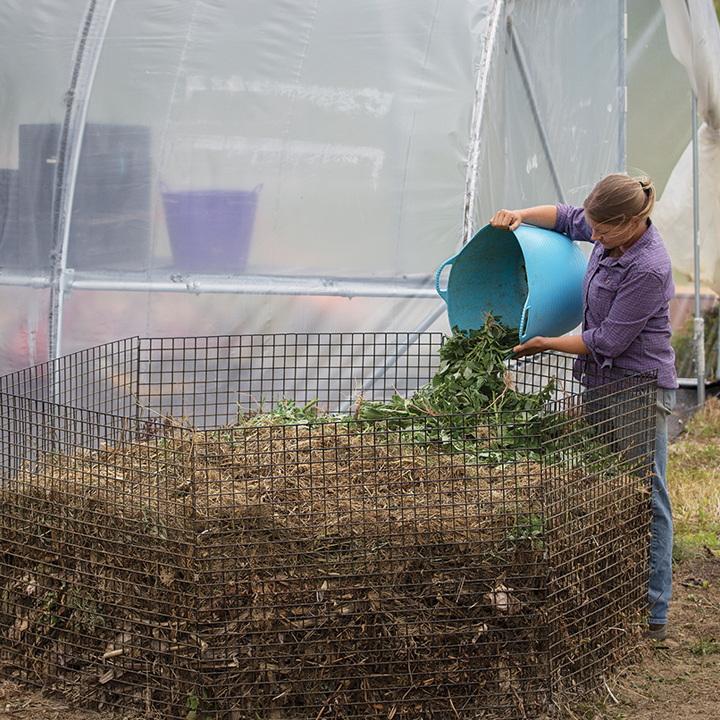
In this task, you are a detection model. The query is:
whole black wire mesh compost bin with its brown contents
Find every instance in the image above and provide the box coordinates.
[0,335,655,720]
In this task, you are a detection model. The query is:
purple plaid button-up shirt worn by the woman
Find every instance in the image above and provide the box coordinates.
[555,204,678,388]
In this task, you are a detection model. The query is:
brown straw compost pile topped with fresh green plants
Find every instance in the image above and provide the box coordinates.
[0,318,648,718]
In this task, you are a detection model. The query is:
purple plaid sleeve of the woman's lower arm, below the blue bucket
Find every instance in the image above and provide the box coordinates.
[582,272,665,367]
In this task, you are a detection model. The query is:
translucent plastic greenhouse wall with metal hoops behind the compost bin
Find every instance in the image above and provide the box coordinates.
[0,0,627,372]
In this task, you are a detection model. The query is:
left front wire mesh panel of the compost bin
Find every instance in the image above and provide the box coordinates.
[0,406,196,716]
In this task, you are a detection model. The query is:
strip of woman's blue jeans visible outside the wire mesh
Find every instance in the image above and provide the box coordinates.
[648,388,675,625]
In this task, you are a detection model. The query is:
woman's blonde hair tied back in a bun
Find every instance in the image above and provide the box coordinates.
[583,173,655,225]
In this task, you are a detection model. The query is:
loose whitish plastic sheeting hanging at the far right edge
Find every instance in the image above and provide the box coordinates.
[653,0,720,292]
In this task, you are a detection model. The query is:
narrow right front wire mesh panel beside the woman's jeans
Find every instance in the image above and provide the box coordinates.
[543,376,655,694]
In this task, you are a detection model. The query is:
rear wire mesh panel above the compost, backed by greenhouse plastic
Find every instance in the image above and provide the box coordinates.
[140,333,444,427]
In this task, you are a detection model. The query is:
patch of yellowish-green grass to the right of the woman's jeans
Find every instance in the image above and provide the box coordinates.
[668,397,720,561]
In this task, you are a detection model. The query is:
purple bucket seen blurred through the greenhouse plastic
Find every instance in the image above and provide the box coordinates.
[163,185,262,273]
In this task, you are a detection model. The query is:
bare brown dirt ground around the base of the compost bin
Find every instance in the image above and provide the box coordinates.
[0,557,720,720]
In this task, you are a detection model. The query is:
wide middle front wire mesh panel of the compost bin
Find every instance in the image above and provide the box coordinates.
[188,419,548,717]
